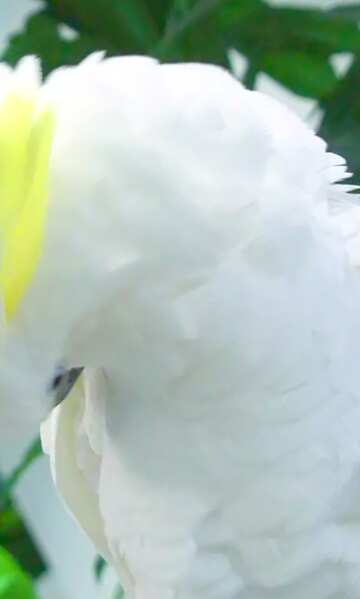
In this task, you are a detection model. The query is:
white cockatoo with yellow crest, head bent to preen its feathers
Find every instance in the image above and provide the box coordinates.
[0,55,360,599]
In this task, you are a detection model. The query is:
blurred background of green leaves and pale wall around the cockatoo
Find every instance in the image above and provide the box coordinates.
[0,0,360,599]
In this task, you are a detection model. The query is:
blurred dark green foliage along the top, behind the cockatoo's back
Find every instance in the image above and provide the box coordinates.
[3,0,360,176]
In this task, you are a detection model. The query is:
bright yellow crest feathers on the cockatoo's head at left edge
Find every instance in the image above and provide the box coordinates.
[0,91,54,319]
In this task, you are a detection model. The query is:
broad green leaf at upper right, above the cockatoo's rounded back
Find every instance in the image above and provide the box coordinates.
[222,0,360,98]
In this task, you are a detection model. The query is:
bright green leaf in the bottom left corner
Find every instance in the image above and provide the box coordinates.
[0,547,37,599]
